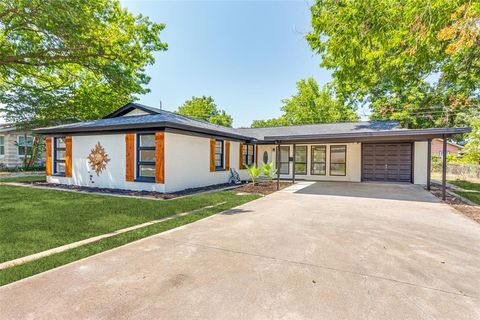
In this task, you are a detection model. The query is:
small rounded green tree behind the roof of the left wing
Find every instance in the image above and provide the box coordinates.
[177,96,233,127]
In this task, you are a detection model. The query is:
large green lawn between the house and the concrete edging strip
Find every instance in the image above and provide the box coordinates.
[0,186,257,262]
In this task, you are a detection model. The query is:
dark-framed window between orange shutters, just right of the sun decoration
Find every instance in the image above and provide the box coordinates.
[137,133,155,182]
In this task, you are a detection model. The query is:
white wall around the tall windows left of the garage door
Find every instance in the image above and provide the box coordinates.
[264,143,362,182]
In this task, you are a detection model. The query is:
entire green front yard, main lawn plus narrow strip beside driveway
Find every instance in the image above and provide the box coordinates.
[0,185,258,285]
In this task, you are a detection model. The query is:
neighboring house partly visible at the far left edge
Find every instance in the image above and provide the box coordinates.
[0,124,45,168]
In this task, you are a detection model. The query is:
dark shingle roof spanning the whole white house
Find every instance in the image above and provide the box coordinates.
[35,103,470,142]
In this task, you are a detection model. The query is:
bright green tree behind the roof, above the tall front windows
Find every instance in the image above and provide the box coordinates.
[252,77,358,128]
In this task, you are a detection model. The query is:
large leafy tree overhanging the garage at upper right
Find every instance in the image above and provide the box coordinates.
[307,0,480,128]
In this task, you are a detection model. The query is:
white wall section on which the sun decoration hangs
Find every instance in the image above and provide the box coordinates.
[47,134,165,192]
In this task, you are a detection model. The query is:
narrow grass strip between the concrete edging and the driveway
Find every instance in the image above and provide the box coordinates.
[0,198,258,286]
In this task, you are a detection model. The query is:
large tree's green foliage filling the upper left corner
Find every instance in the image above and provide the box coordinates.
[0,0,167,124]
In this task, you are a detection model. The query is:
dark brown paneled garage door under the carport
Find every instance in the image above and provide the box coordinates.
[362,143,412,182]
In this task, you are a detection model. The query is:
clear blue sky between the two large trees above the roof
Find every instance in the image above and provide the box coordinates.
[121,0,342,127]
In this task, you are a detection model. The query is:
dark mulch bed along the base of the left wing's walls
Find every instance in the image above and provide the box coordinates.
[22,181,244,199]
